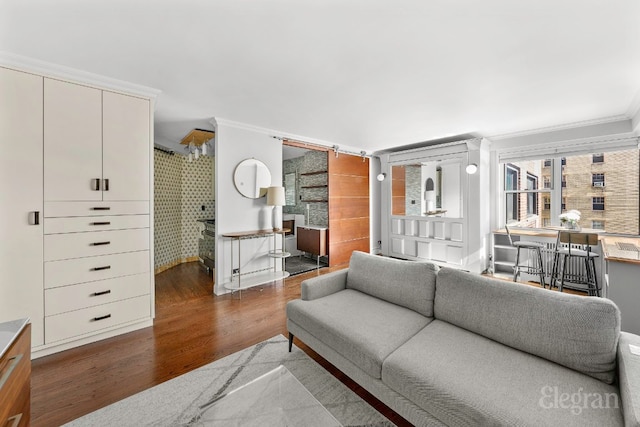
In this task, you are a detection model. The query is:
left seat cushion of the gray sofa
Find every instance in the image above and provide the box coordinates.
[287,289,432,379]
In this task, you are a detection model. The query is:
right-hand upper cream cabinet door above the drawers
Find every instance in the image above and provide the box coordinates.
[103,91,151,201]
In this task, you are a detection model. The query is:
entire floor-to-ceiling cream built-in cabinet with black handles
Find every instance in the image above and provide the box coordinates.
[0,63,154,356]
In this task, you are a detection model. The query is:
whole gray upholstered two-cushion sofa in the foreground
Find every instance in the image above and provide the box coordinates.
[286,252,640,426]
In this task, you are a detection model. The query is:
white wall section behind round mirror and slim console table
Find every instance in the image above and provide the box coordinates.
[214,119,282,294]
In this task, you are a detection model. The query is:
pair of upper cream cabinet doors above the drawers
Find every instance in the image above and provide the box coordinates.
[44,78,149,201]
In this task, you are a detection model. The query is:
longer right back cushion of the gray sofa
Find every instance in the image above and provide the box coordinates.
[434,268,620,384]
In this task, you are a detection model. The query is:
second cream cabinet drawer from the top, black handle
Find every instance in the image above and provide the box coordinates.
[44,215,149,234]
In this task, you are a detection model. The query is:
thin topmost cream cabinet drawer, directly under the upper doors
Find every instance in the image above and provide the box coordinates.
[44,201,149,218]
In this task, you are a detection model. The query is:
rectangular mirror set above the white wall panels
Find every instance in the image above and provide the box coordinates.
[390,155,466,218]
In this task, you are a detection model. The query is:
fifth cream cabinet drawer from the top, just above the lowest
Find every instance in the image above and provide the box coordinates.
[44,273,151,316]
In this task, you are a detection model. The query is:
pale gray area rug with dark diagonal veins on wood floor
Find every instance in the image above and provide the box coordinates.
[66,335,394,427]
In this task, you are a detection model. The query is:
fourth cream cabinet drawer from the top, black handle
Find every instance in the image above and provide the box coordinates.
[44,251,150,289]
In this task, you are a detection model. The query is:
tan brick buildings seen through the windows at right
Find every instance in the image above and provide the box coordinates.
[503,149,640,235]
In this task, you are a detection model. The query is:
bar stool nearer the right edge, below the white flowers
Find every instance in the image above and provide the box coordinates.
[549,231,600,296]
